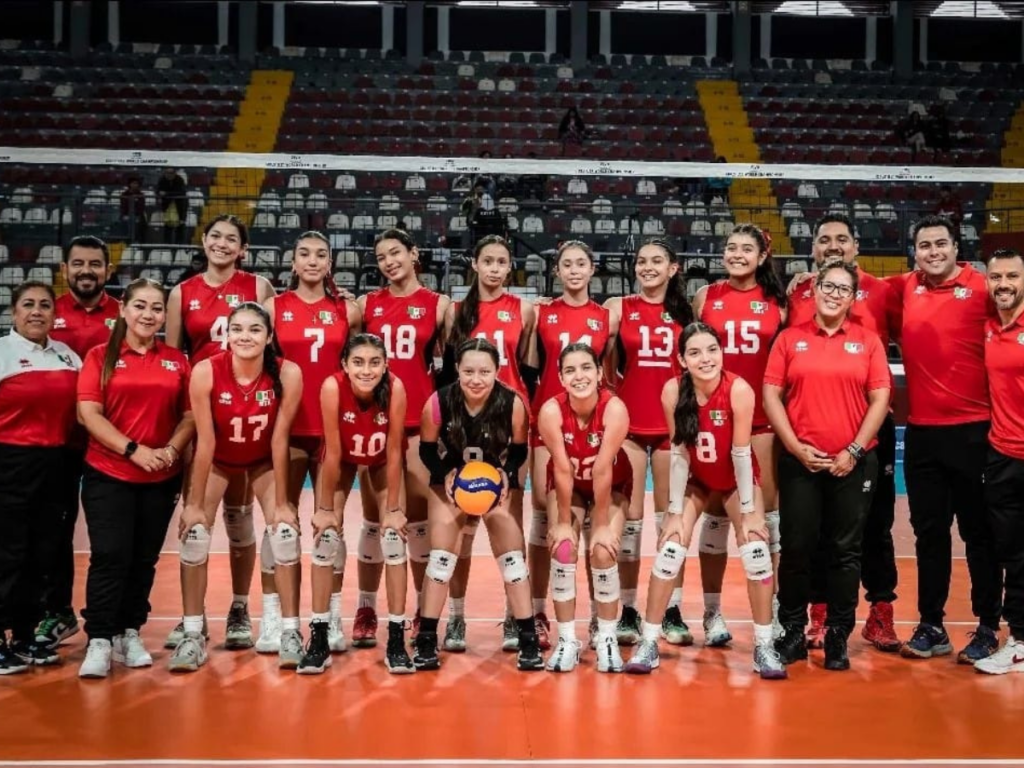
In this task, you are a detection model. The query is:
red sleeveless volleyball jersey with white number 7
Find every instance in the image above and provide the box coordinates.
[273,291,348,437]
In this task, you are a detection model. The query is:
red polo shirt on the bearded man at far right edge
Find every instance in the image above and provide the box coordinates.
[985,317,1024,461]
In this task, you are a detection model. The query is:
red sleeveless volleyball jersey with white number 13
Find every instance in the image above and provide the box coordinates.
[618,296,683,435]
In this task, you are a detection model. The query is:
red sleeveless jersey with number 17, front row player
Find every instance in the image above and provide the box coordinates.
[210,352,280,469]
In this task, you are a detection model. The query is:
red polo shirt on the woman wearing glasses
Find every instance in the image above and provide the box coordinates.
[765,321,890,456]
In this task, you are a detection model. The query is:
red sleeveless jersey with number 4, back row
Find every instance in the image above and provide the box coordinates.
[180,269,257,366]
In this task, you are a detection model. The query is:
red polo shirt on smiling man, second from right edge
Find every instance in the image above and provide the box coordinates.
[888,263,995,426]
